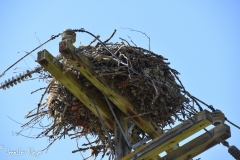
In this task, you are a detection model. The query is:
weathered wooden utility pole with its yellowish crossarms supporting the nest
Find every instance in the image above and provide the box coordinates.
[34,30,239,160]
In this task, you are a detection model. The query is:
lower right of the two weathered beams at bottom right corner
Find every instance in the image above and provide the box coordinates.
[163,124,231,160]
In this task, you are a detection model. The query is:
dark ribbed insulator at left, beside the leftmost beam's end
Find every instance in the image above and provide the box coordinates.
[0,67,41,90]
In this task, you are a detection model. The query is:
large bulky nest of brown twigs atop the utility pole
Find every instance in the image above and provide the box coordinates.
[22,33,199,157]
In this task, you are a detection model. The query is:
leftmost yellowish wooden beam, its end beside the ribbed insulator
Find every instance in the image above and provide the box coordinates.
[37,50,114,130]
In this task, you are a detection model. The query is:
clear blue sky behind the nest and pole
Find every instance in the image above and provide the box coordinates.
[0,0,240,160]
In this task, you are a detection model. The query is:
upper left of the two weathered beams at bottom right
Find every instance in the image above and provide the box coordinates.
[122,110,212,160]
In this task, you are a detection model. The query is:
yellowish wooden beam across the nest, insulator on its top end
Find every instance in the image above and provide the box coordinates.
[59,40,161,137]
